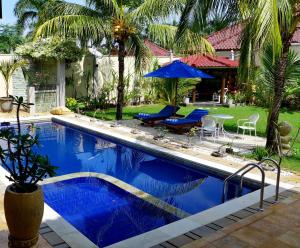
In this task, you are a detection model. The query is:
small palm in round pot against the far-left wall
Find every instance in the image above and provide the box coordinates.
[0,60,28,112]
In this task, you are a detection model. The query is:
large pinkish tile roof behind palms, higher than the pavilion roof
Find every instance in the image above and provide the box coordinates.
[207,23,300,51]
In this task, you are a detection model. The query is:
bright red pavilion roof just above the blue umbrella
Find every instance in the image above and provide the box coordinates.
[181,54,239,68]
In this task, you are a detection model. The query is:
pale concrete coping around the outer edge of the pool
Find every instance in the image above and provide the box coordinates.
[0,117,293,248]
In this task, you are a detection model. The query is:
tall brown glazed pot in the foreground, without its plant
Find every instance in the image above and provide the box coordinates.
[4,184,44,248]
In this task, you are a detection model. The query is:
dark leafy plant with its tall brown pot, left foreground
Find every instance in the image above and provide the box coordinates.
[0,97,56,248]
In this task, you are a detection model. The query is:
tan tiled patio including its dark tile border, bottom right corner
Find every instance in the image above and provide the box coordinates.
[152,191,300,248]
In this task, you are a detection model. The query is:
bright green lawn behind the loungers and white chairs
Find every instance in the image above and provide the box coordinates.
[87,104,300,171]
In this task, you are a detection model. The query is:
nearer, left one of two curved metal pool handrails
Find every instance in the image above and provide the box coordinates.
[223,163,265,211]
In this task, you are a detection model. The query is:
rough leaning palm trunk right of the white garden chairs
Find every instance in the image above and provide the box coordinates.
[266,45,290,151]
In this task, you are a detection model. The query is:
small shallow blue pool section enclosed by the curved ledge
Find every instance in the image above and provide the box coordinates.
[43,177,178,247]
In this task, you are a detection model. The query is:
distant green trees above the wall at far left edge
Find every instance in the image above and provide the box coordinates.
[0,24,24,54]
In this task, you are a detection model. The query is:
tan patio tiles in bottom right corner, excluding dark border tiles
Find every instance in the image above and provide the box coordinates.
[183,190,300,248]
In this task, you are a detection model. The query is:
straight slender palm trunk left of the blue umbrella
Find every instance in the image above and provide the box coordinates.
[116,41,125,120]
